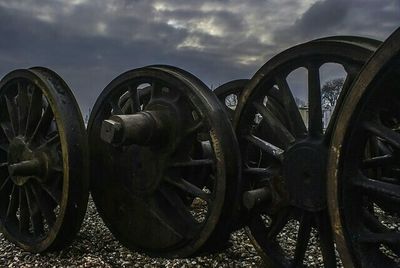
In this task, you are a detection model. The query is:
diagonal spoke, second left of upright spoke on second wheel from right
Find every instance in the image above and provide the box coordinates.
[253,102,295,147]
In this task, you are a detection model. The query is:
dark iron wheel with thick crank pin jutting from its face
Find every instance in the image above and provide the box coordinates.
[88,63,241,257]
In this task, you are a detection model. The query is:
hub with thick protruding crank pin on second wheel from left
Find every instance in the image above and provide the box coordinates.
[101,103,178,195]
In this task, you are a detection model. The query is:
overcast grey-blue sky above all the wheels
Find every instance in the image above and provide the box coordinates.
[0,0,400,114]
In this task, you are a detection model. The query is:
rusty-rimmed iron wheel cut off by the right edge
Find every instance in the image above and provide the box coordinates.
[328,29,400,267]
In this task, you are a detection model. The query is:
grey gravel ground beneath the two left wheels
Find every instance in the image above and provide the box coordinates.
[0,196,262,268]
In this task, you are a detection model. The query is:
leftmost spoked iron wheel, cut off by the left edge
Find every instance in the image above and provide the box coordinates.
[0,67,89,252]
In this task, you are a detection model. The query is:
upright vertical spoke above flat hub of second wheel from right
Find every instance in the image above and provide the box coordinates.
[307,64,323,136]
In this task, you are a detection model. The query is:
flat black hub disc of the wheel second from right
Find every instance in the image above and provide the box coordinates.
[283,141,327,211]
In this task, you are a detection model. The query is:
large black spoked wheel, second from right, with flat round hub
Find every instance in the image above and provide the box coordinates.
[234,37,382,267]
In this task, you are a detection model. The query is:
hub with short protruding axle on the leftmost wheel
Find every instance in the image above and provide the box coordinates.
[8,137,46,186]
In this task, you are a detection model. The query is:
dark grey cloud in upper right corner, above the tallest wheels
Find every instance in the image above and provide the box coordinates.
[274,0,400,44]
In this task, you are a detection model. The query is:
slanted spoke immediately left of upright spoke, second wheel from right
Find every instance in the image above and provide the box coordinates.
[275,75,307,137]
